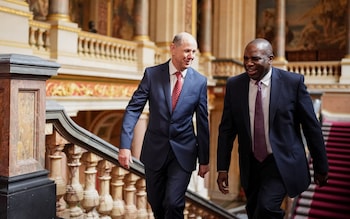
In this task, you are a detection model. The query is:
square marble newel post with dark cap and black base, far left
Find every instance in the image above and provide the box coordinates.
[0,54,59,218]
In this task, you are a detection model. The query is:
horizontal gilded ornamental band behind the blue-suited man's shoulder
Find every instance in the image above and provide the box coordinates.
[46,81,137,98]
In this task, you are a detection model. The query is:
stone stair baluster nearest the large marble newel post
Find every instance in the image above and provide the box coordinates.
[46,130,68,217]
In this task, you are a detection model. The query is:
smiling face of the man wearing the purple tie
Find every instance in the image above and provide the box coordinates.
[244,44,273,80]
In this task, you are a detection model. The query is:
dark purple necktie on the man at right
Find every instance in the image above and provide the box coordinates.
[254,81,267,162]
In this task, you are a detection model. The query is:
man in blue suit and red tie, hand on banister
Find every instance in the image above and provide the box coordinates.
[118,32,209,219]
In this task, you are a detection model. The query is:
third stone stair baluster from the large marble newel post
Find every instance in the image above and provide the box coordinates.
[81,152,100,219]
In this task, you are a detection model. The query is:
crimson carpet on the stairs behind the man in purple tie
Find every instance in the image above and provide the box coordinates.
[292,121,350,219]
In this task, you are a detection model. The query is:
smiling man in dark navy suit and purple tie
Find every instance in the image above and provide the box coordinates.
[217,39,328,219]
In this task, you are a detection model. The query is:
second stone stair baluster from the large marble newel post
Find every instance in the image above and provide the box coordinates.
[64,145,84,219]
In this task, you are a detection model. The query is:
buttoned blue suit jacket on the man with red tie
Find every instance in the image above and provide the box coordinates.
[120,61,209,172]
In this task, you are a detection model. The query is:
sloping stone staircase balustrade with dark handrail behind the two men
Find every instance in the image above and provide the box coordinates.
[46,101,236,219]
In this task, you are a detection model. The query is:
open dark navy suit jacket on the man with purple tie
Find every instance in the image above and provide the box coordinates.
[217,68,328,197]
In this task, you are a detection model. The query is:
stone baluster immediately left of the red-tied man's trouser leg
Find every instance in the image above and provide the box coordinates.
[136,178,148,219]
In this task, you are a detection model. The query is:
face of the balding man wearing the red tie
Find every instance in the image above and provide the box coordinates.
[170,38,197,71]
